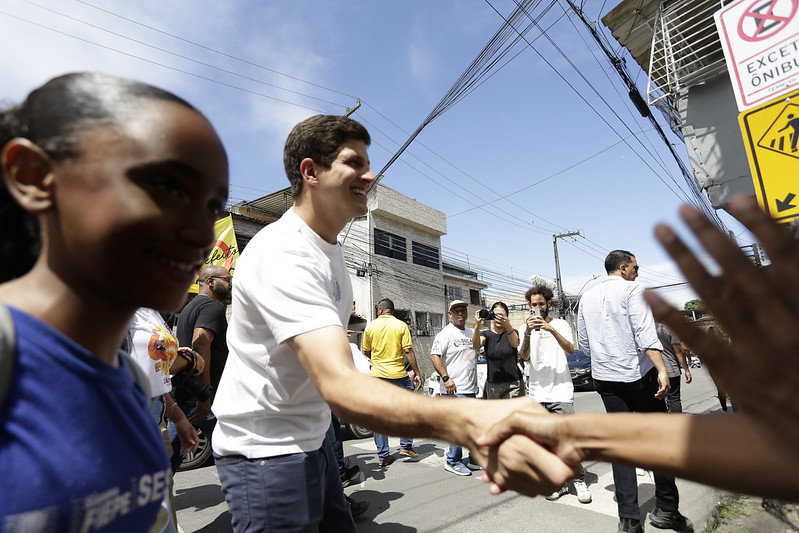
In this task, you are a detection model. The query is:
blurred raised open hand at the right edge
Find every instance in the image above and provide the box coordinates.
[645,198,799,442]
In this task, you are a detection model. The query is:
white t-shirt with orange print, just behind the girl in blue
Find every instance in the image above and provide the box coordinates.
[128,307,178,398]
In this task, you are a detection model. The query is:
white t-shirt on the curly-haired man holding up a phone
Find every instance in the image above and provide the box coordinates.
[519,318,574,403]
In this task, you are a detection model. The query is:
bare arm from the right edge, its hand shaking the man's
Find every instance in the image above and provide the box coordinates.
[478,409,799,501]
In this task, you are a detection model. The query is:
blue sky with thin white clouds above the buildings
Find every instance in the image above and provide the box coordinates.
[0,0,748,306]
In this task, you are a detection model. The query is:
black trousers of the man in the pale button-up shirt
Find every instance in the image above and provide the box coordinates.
[594,368,680,520]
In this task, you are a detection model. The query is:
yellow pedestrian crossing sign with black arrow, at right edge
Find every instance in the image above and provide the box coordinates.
[738,91,799,222]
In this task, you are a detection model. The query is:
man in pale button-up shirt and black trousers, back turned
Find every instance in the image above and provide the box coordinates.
[577,250,693,533]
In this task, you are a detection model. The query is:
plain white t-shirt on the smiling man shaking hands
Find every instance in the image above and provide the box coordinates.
[212,209,352,459]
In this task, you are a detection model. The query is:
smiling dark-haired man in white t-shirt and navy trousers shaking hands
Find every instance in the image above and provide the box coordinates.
[212,115,572,533]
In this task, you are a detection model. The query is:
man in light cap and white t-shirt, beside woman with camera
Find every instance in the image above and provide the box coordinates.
[430,300,480,476]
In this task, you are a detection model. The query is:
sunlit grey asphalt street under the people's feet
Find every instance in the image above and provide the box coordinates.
[175,369,719,533]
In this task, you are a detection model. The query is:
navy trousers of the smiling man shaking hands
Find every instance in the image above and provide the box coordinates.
[214,438,357,533]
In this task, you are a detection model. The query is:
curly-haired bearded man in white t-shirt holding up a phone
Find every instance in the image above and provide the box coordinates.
[519,285,591,503]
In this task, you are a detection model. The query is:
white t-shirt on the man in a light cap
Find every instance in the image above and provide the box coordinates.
[430,323,477,394]
